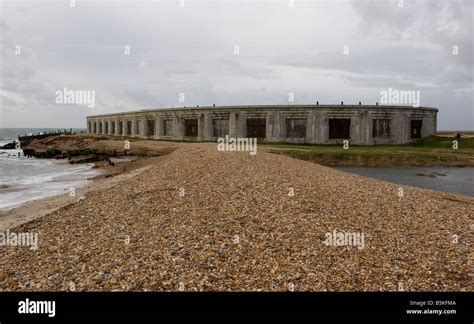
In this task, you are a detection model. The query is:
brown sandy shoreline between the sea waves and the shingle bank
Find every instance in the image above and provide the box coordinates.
[0,135,178,231]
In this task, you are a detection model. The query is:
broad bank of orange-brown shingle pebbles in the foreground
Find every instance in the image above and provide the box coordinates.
[0,143,474,291]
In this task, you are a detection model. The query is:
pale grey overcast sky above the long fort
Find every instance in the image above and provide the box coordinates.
[0,0,474,130]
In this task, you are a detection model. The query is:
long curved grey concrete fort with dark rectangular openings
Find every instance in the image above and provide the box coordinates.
[87,104,438,145]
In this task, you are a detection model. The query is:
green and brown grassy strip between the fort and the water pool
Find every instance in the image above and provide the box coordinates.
[259,136,474,167]
